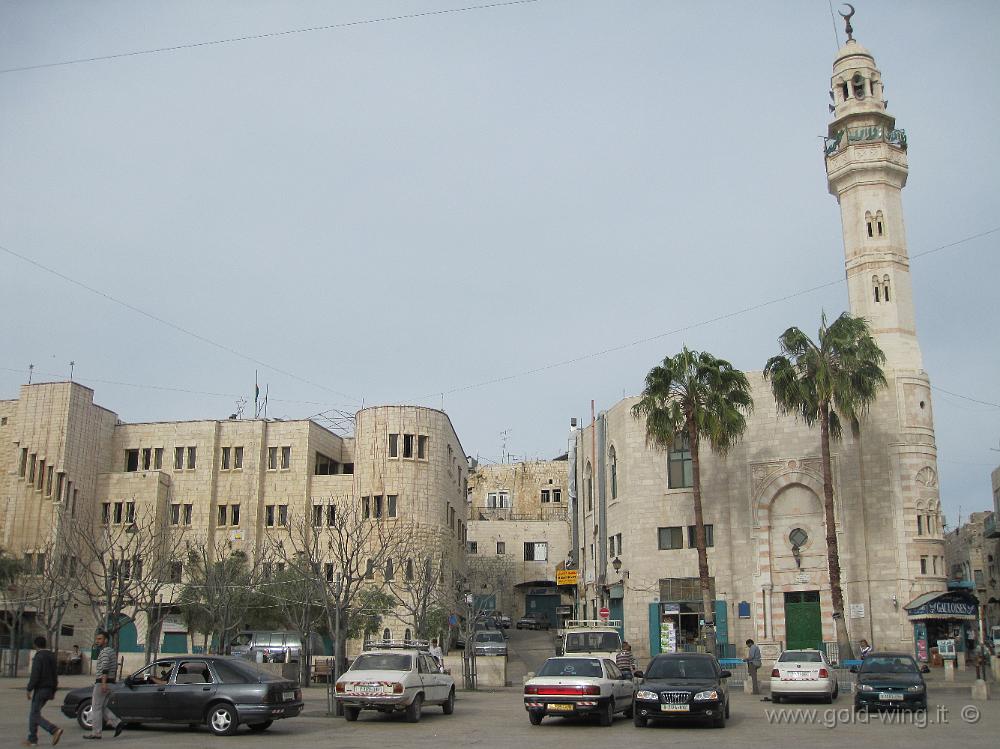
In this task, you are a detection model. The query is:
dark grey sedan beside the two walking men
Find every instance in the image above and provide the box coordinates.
[62,655,302,736]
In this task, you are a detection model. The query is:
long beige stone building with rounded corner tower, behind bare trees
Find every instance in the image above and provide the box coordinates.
[0,382,468,651]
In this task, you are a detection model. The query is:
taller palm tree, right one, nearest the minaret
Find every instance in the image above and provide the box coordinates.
[764,312,886,661]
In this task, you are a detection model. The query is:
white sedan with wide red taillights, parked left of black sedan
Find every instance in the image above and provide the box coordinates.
[524,656,634,726]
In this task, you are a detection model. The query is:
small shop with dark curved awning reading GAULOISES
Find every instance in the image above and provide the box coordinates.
[903,589,979,663]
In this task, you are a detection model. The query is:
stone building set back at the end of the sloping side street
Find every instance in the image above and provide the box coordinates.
[468,458,573,626]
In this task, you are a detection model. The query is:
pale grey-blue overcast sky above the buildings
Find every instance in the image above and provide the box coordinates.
[0,0,1000,525]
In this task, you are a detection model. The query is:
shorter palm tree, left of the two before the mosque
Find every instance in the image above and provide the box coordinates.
[632,346,753,650]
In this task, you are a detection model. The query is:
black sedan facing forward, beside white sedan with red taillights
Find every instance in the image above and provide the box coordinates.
[633,653,732,728]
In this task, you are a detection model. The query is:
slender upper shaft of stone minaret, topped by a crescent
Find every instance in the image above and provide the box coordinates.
[826,24,923,370]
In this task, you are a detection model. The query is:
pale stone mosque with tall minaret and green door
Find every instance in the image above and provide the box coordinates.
[573,27,947,656]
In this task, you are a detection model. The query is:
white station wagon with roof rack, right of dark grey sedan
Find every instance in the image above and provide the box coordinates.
[335,642,455,723]
